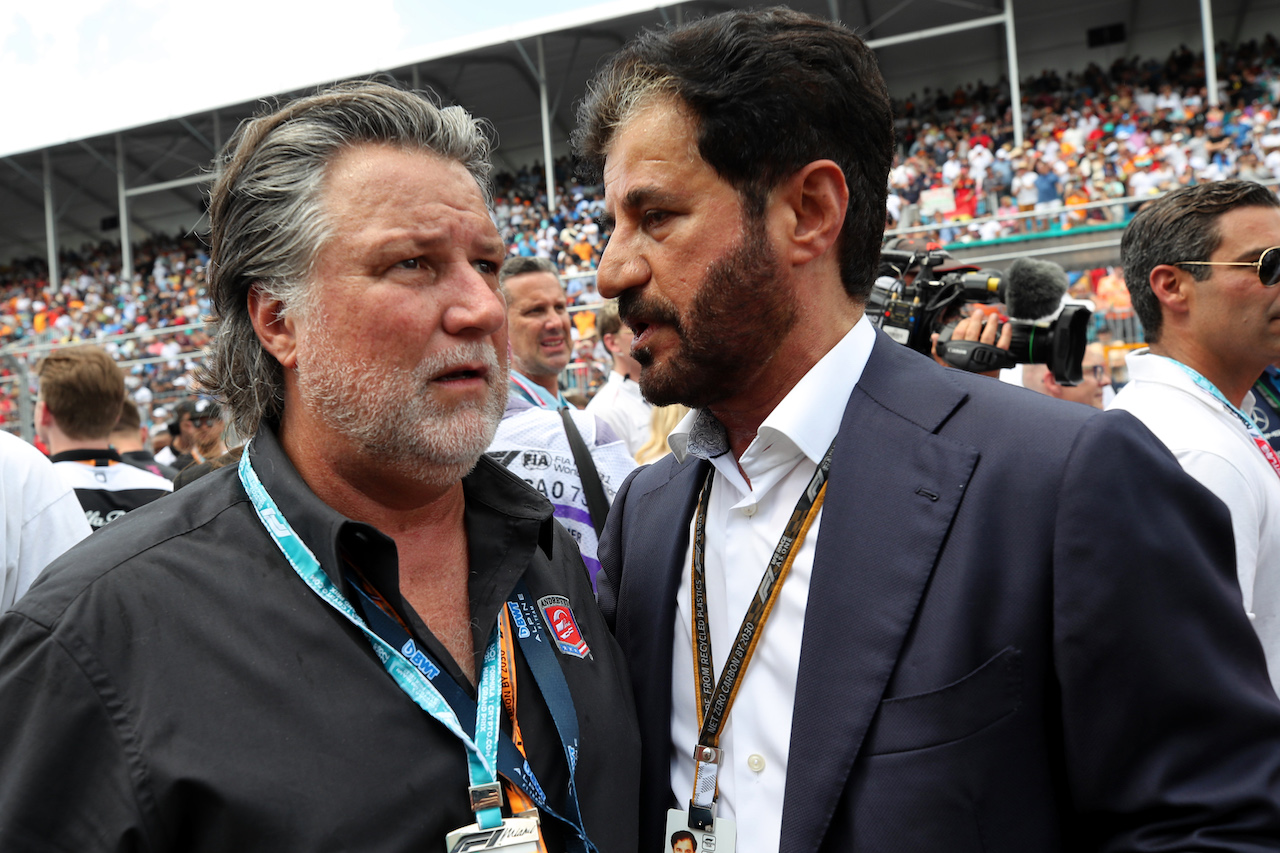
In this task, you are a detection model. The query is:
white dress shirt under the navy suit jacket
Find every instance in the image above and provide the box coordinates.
[668,318,876,853]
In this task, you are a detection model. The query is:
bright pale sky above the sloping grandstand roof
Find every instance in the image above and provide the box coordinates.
[0,0,614,155]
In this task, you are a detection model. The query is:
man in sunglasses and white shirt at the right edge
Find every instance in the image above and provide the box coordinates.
[1111,181,1280,686]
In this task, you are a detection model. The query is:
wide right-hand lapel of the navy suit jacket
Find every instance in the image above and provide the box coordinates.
[778,334,978,853]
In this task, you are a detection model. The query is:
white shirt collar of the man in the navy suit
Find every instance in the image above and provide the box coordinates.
[667,315,876,464]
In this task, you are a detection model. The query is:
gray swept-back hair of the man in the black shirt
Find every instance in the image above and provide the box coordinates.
[198,81,493,435]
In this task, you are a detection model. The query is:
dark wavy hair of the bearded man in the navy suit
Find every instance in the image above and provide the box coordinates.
[572,6,893,300]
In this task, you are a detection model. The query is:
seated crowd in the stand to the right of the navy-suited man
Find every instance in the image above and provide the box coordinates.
[887,35,1280,243]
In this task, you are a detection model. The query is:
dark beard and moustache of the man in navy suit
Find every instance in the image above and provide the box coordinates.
[618,218,796,409]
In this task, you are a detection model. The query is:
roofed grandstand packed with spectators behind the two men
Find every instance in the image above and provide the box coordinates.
[0,0,1280,438]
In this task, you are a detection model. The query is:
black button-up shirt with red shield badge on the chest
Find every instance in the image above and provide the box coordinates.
[0,429,639,853]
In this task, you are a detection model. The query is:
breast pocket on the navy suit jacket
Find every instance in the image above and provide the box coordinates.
[861,647,1023,756]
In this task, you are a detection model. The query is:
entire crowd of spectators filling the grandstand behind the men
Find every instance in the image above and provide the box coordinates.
[0,35,1280,432]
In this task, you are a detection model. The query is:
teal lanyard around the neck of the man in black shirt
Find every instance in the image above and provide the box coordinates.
[239,442,502,829]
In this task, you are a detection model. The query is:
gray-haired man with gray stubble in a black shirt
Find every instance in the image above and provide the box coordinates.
[0,83,639,853]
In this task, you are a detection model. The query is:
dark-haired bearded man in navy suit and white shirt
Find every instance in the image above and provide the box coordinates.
[575,9,1280,853]
